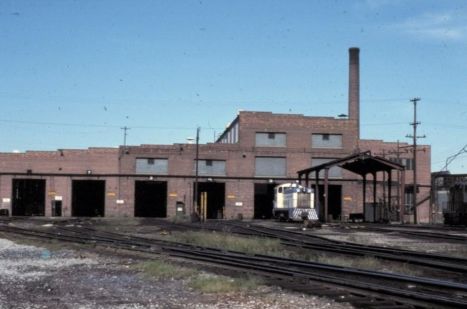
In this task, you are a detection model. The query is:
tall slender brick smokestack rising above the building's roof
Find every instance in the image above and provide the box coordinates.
[349,47,360,139]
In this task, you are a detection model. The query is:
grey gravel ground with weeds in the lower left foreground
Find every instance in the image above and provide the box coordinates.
[0,238,352,309]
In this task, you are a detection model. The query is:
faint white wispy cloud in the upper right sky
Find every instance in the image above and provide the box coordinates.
[394,12,467,41]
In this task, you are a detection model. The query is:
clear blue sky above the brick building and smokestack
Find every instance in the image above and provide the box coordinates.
[0,0,467,173]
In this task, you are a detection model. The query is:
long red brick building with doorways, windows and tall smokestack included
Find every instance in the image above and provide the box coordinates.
[0,48,431,222]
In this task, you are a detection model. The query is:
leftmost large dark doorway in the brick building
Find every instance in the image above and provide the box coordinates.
[12,179,45,216]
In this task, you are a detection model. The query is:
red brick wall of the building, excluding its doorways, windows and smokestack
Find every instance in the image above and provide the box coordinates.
[0,112,431,222]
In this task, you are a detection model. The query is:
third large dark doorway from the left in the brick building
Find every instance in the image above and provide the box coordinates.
[135,181,167,218]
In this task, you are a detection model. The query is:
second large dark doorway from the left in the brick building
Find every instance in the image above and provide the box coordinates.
[71,180,105,217]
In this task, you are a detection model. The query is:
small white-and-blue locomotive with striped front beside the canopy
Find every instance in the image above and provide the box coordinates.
[272,183,318,221]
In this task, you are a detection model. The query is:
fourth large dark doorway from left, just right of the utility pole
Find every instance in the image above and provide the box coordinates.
[193,182,225,219]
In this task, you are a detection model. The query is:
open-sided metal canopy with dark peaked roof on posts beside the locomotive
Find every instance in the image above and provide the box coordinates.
[297,151,405,222]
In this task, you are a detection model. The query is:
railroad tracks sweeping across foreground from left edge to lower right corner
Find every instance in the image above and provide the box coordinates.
[0,225,467,308]
